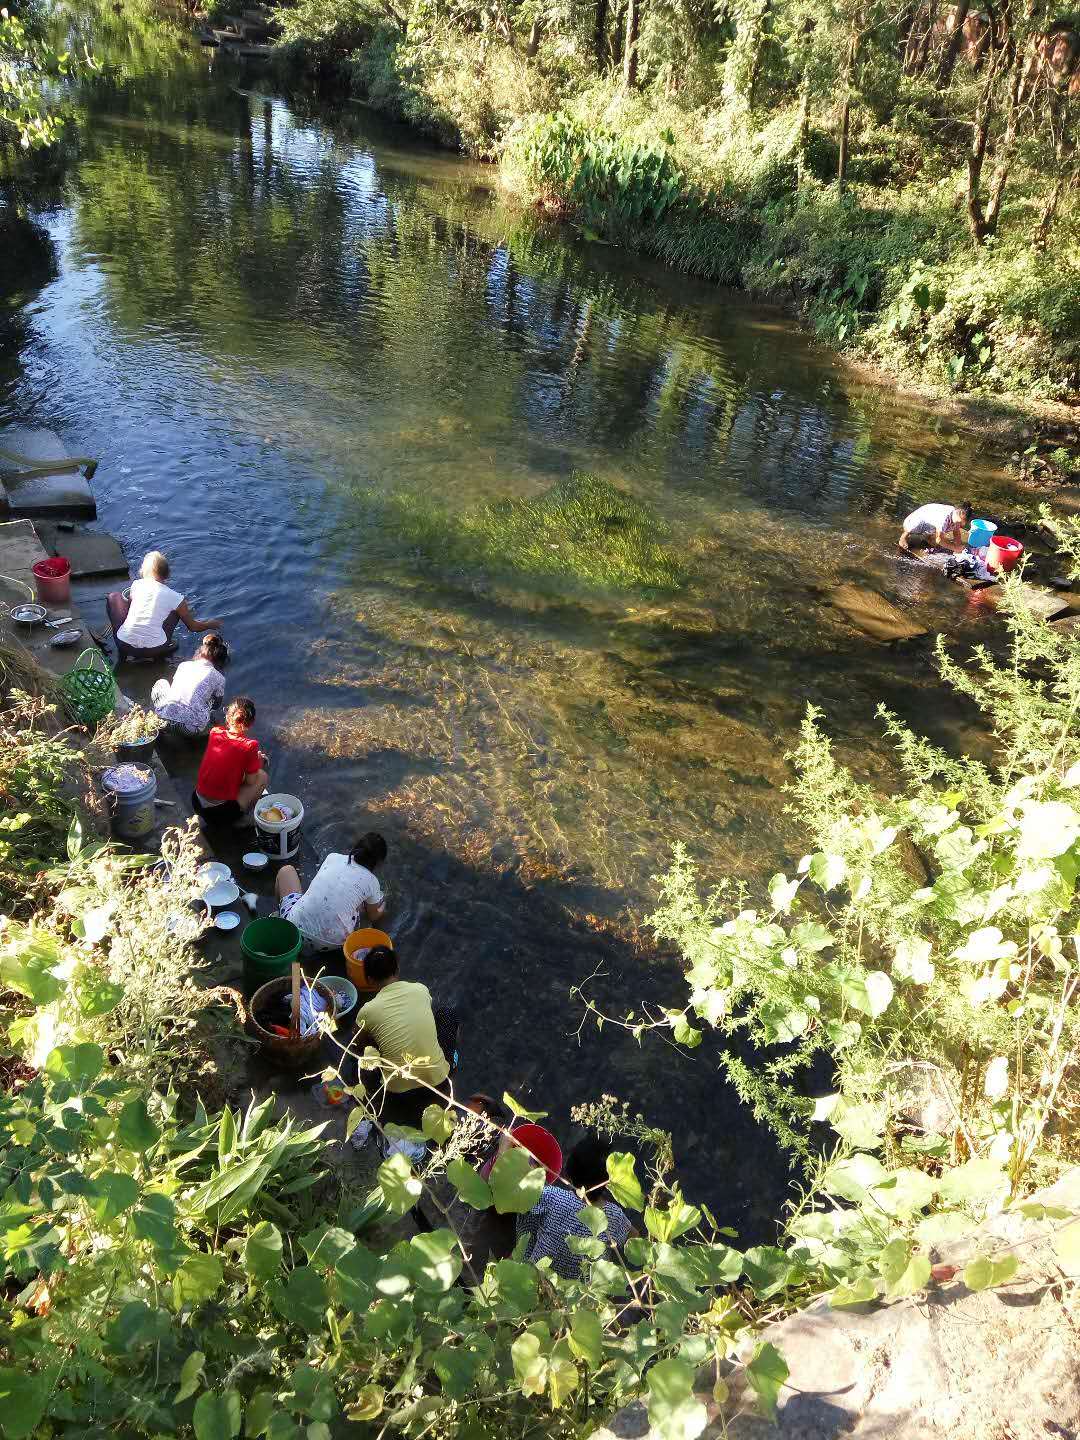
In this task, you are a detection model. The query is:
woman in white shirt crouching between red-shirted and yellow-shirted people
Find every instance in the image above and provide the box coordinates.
[275,831,386,950]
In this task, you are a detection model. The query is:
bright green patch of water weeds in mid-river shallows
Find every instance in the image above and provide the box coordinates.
[390,471,685,595]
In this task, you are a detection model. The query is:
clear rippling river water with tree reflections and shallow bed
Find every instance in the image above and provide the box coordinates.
[0,50,1031,1238]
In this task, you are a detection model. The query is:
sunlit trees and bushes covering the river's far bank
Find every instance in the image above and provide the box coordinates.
[269,0,1080,399]
